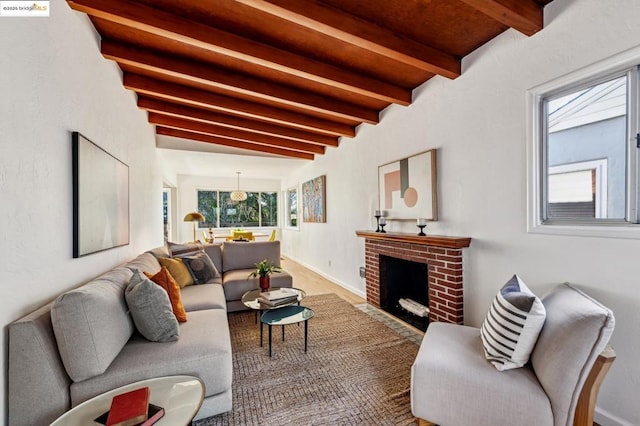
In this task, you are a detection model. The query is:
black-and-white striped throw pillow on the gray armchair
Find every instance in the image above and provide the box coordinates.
[480,275,546,371]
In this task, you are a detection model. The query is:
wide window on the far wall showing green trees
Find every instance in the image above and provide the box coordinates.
[197,190,278,228]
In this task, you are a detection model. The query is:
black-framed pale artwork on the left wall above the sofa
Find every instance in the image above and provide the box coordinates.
[72,132,129,258]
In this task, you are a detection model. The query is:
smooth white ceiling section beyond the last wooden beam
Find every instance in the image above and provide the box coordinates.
[156,135,309,179]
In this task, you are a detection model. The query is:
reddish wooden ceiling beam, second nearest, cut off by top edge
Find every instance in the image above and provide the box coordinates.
[236,0,461,78]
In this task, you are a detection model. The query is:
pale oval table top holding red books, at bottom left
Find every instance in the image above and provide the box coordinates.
[51,376,204,426]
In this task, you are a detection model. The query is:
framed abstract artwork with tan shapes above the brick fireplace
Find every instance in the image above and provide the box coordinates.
[378,149,438,220]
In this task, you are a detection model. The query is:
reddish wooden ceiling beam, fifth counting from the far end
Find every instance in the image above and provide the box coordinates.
[101,40,379,124]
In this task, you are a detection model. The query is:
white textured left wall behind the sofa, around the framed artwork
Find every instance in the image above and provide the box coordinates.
[0,1,162,423]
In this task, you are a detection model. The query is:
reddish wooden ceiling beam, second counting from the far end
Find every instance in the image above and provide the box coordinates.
[148,112,325,154]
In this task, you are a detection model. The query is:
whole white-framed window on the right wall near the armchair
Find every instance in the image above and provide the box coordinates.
[529,59,640,236]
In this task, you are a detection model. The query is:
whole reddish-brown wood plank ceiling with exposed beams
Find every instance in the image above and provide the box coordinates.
[68,0,552,160]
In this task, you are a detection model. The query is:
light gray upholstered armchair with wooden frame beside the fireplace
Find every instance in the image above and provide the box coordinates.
[411,284,615,426]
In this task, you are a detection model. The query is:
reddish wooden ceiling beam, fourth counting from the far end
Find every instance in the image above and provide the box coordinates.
[123,73,355,137]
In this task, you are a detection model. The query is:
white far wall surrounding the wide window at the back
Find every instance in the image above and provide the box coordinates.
[174,175,282,242]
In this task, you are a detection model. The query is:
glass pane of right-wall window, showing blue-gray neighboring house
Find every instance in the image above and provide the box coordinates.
[544,76,627,219]
